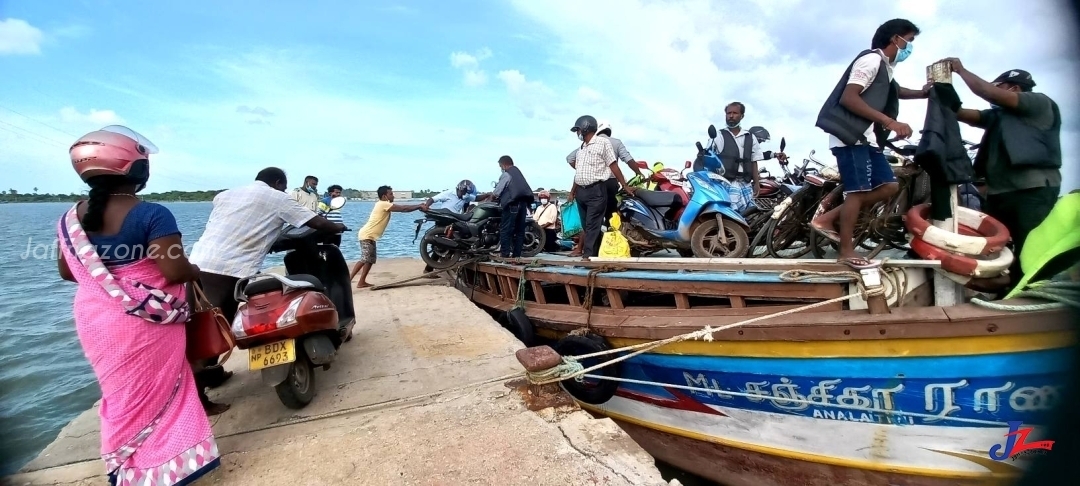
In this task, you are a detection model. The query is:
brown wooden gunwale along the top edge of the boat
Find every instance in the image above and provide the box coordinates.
[455,264,1075,341]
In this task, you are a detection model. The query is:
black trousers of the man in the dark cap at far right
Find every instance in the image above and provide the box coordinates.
[985,187,1062,285]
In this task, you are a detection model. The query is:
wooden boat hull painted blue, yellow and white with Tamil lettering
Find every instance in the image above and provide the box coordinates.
[455,255,1076,486]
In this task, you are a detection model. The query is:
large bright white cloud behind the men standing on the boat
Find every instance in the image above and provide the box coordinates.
[500,0,1080,187]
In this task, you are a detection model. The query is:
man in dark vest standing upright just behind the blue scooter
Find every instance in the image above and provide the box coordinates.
[713,102,787,212]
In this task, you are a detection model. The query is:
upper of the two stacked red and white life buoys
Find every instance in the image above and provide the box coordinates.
[904,203,1009,256]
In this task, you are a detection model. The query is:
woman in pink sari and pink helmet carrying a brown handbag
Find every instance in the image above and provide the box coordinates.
[57,125,220,485]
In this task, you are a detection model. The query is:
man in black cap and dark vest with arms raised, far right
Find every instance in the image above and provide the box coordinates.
[945,57,1062,284]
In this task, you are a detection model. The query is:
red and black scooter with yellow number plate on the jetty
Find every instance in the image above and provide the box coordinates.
[232,198,356,408]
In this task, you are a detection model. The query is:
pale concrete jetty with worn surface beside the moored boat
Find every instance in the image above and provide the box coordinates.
[2,259,677,486]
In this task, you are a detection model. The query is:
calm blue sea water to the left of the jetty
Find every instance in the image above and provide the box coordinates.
[0,201,422,475]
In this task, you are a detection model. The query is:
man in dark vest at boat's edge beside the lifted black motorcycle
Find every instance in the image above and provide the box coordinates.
[491,156,532,258]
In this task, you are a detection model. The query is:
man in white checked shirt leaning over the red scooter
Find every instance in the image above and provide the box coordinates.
[188,167,346,413]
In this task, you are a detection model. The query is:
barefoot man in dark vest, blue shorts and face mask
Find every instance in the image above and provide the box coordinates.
[811,18,930,270]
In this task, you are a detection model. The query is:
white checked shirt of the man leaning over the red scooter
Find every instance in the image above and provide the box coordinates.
[189,180,315,279]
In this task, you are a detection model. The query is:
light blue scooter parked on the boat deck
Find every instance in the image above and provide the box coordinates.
[619,126,750,258]
